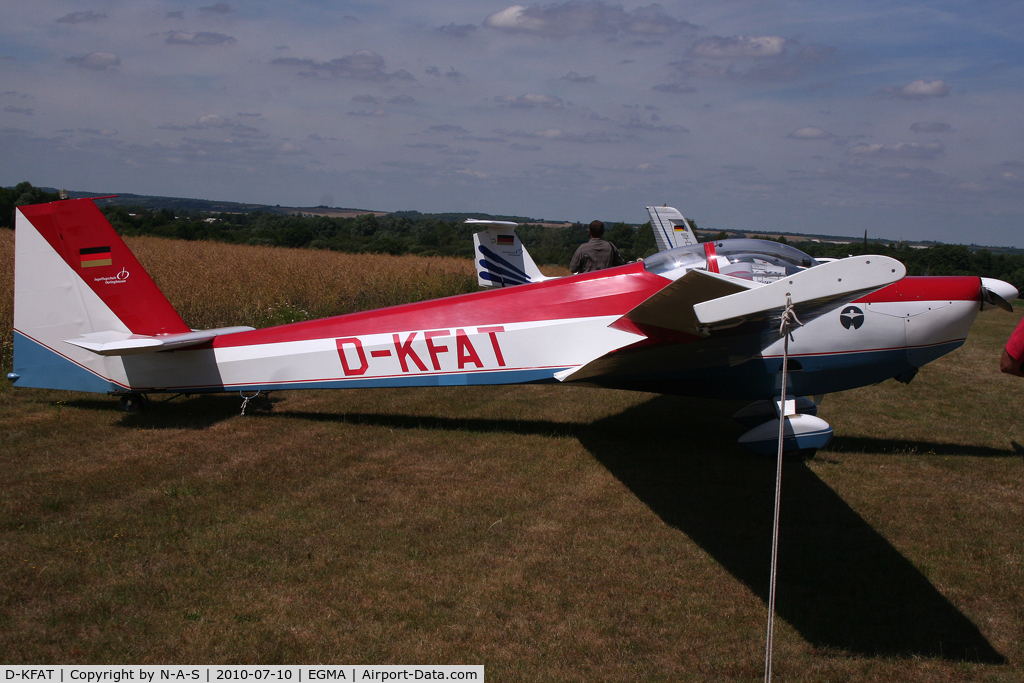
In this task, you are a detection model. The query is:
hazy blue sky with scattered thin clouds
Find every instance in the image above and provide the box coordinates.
[0,0,1024,247]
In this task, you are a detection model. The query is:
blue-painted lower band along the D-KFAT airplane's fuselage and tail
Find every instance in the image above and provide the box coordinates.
[13,332,963,399]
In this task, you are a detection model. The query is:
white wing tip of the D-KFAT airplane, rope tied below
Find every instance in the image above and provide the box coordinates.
[693,255,906,328]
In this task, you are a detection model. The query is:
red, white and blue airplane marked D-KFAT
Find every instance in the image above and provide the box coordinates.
[8,199,1017,450]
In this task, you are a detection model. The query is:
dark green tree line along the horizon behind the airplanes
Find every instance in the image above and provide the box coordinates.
[6,182,1024,291]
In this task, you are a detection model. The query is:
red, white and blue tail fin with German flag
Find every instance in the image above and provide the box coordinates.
[11,199,190,392]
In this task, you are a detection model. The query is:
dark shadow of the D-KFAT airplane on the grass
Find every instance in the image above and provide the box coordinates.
[289,396,1013,664]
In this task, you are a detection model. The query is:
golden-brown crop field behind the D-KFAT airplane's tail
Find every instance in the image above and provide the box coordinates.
[0,230,477,375]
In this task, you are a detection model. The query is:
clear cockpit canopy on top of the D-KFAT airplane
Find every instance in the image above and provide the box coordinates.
[643,240,818,283]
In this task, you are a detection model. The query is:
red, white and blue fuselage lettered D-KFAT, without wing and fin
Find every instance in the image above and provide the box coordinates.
[15,250,981,398]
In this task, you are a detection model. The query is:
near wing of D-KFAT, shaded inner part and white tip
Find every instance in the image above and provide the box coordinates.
[555,256,906,382]
